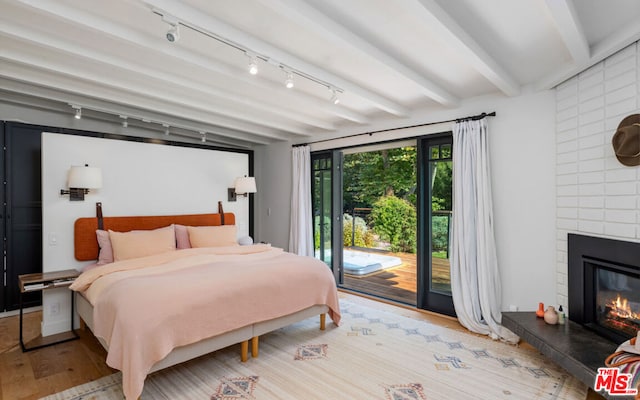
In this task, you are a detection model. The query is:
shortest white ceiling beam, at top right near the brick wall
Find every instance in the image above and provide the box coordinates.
[545,0,590,64]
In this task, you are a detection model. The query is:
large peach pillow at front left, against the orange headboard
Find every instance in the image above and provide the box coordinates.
[109,225,176,261]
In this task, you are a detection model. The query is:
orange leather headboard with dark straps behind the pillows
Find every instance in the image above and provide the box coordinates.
[73,213,236,261]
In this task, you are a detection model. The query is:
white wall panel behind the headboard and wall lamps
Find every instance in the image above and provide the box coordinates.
[42,133,249,335]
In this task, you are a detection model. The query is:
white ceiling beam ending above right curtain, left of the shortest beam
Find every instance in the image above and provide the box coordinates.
[410,0,520,96]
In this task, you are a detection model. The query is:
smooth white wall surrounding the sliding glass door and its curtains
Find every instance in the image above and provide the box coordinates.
[256,88,556,310]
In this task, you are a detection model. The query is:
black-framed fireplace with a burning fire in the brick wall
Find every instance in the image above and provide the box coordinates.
[568,234,640,344]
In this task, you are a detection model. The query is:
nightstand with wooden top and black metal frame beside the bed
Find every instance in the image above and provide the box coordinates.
[18,269,80,352]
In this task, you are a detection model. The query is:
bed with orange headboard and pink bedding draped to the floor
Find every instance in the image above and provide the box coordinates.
[71,203,340,400]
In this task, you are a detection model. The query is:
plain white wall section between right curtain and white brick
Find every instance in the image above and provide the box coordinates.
[489,91,555,311]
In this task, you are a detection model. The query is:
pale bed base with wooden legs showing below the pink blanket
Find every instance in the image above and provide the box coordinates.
[75,292,329,373]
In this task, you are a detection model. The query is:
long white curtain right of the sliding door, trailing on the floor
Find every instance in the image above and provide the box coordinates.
[451,118,519,343]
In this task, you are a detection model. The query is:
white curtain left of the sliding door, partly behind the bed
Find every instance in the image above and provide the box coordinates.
[289,146,313,257]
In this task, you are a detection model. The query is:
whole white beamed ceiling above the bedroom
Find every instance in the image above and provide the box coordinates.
[0,0,640,147]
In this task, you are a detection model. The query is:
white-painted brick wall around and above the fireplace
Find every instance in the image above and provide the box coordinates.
[556,43,640,312]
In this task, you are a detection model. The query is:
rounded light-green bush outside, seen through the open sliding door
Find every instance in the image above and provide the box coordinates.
[371,196,417,253]
